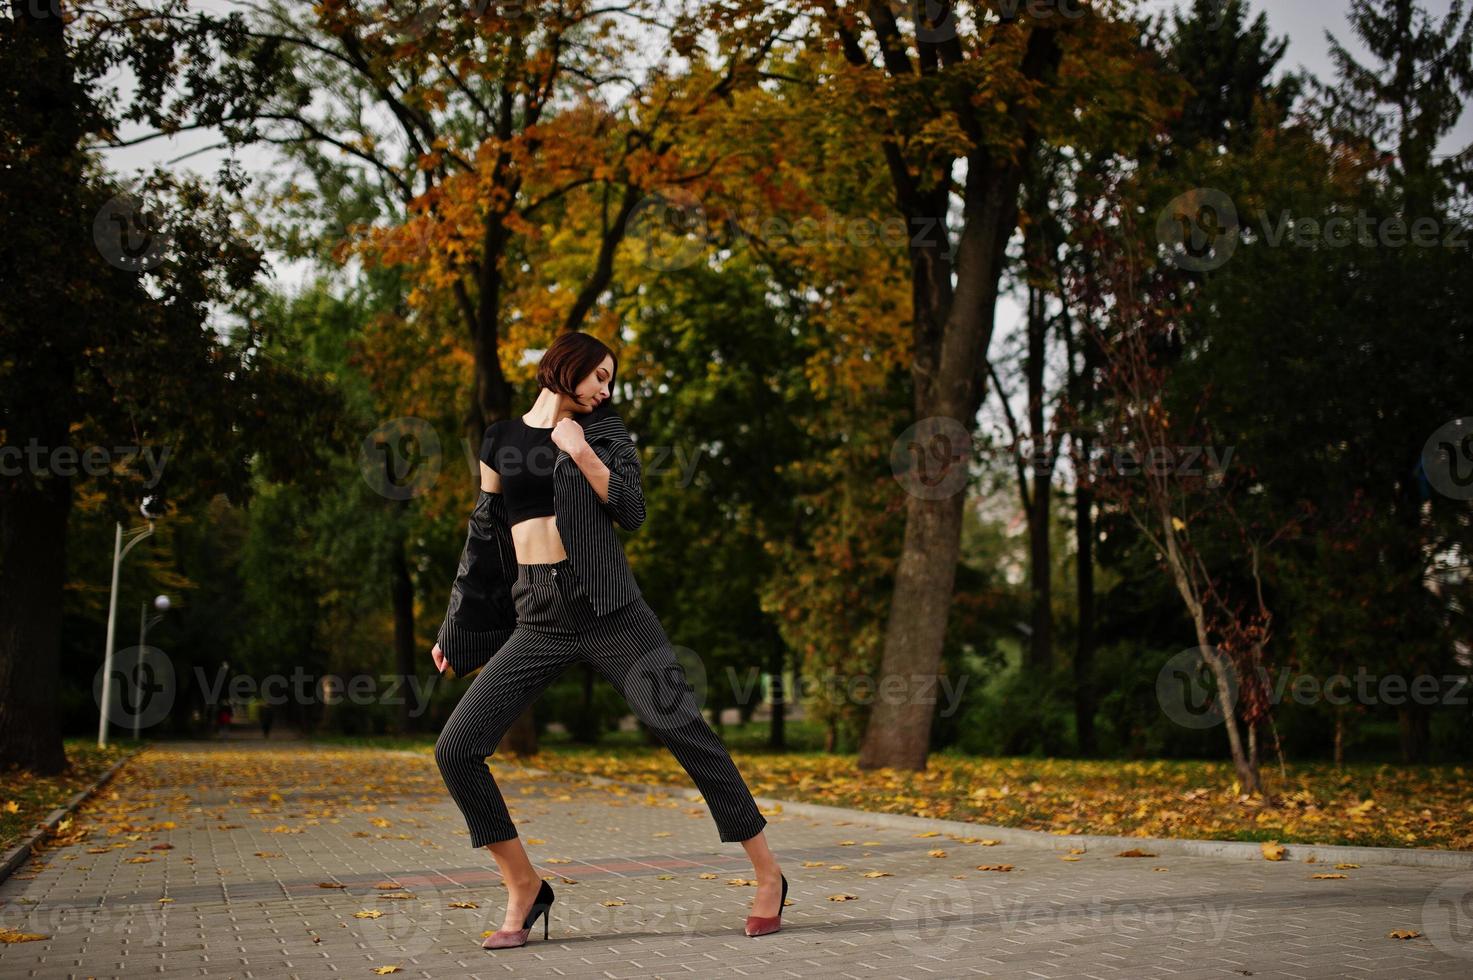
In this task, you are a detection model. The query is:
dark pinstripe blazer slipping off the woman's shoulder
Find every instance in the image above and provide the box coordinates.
[437,401,645,676]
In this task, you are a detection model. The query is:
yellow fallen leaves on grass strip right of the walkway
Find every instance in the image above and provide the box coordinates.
[527,747,1473,850]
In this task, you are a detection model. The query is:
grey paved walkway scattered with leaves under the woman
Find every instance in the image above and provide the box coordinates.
[0,741,1473,980]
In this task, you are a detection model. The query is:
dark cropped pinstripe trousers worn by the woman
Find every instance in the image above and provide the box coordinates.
[435,559,767,847]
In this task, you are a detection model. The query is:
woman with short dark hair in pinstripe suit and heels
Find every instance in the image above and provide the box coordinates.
[430,333,788,949]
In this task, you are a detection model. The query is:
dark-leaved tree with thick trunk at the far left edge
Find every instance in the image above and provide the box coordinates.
[0,0,336,772]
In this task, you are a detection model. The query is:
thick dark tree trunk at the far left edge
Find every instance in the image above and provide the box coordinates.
[0,0,86,775]
